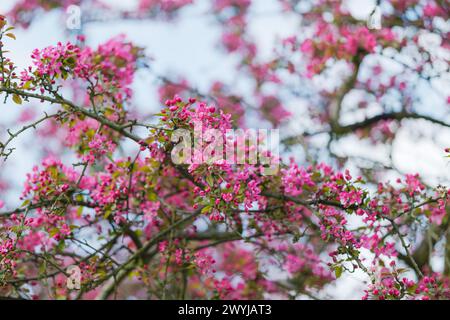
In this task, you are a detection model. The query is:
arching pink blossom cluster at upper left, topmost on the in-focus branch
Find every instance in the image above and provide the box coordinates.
[20,36,142,108]
